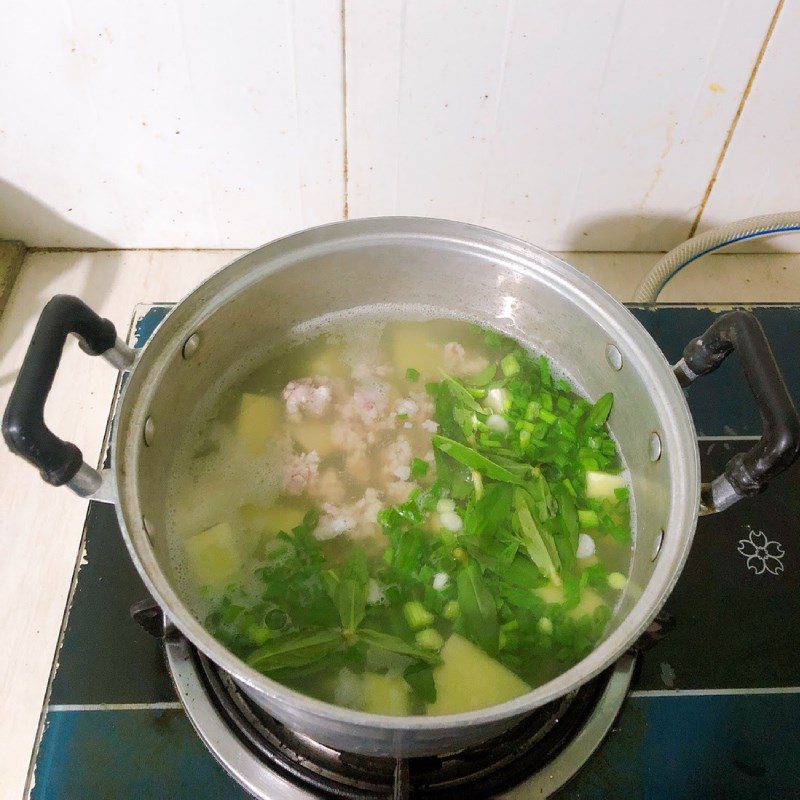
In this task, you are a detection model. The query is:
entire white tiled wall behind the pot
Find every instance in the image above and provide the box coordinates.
[0,0,800,250]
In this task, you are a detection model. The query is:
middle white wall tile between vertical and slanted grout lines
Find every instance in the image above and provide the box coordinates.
[345,0,774,250]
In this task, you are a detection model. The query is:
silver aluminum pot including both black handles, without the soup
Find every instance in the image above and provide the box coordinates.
[3,218,800,756]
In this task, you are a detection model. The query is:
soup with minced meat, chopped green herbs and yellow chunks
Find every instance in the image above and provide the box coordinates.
[168,311,632,715]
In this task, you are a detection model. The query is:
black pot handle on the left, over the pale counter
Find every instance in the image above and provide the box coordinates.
[3,294,136,497]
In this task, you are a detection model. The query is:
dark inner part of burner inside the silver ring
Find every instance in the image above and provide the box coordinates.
[190,647,624,800]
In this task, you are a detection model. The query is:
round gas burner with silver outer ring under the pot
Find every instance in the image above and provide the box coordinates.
[166,637,635,800]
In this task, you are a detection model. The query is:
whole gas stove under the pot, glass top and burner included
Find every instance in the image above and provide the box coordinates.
[23,304,800,800]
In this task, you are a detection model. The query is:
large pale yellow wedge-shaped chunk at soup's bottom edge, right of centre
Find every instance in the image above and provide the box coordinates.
[428,633,531,714]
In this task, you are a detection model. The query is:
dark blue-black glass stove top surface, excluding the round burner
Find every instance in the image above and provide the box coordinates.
[25,305,800,800]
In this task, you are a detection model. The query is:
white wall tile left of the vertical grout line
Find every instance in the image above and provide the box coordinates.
[0,0,344,247]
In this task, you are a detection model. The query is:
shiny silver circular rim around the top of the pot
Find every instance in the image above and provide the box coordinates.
[111,216,700,732]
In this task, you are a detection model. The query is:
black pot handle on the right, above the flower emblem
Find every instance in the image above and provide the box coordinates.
[673,309,800,513]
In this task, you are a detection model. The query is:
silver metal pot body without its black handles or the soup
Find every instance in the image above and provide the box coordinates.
[112,218,700,756]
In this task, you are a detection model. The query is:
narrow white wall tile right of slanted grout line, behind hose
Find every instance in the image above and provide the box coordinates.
[699,0,800,252]
